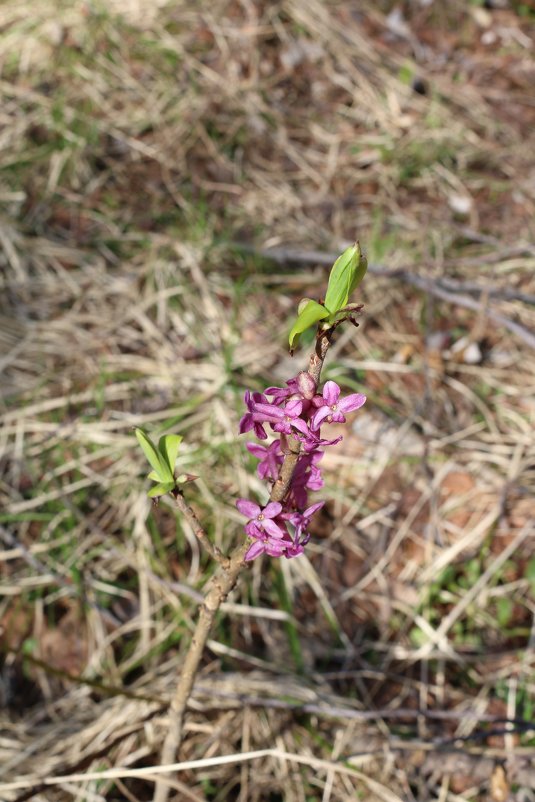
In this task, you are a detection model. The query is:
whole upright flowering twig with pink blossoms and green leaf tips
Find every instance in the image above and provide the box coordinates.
[147,245,366,802]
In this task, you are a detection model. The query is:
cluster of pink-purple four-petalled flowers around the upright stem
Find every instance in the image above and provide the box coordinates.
[236,371,366,560]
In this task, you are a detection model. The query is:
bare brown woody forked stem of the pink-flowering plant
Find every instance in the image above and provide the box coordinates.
[154,329,332,802]
